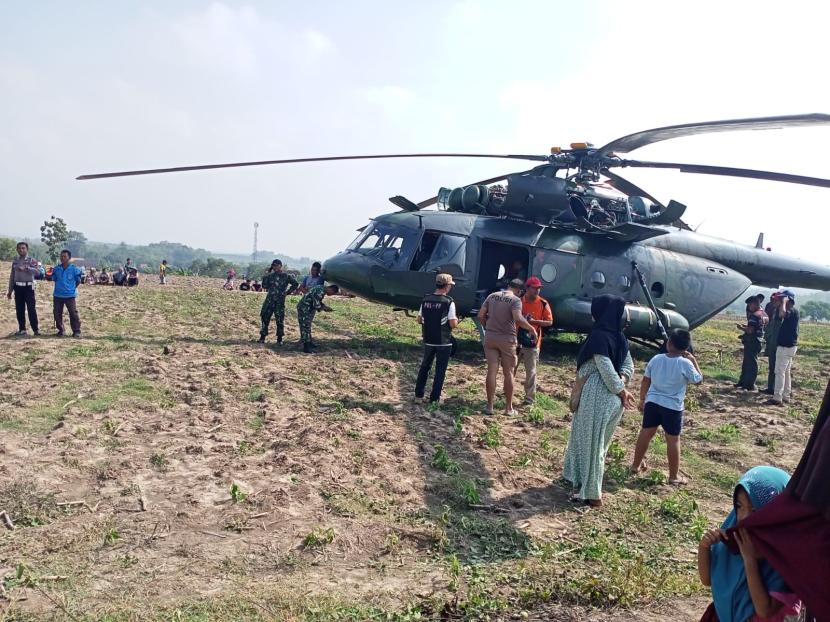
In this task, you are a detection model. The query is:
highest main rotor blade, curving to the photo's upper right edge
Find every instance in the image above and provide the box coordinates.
[597,113,830,157]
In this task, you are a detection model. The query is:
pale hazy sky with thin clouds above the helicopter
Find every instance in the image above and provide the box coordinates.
[0,0,830,263]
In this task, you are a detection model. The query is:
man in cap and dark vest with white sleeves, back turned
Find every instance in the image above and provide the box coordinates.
[415,274,458,403]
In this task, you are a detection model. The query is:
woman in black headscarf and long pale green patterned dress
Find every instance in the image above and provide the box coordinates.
[563,294,634,507]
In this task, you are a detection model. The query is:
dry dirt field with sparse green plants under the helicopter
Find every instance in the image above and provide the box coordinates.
[0,264,830,622]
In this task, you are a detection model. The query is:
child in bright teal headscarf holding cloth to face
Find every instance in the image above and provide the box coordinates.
[697,466,801,622]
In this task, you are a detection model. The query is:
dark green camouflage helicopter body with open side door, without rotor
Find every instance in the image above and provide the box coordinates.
[323,211,830,340]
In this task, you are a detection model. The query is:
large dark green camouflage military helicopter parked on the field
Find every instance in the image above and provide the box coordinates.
[77,114,830,346]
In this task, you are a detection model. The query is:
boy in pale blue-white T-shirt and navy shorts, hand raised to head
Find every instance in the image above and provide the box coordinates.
[631,330,703,485]
